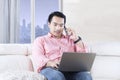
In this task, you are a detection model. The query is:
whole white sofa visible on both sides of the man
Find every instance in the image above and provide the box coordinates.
[0,42,120,80]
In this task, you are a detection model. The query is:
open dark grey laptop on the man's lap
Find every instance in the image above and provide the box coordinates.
[58,52,96,72]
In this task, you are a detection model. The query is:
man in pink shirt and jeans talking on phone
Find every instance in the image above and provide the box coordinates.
[33,11,92,80]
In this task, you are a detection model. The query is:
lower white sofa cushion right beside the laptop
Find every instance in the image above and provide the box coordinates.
[91,56,120,80]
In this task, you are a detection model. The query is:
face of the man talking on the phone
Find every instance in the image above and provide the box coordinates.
[48,16,64,38]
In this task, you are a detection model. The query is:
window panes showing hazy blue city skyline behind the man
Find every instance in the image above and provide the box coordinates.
[19,0,60,43]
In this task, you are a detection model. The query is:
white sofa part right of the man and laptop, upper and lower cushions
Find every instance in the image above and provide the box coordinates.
[90,42,120,80]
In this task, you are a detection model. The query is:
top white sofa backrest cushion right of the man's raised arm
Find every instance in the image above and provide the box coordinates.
[91,42,120,56]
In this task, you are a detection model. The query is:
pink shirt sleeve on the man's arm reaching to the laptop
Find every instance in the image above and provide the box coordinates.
[32,38,49,72]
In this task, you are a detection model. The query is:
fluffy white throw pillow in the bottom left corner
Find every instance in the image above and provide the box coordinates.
[0,71,45,80]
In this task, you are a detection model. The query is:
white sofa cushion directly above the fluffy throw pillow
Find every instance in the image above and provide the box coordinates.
[0,55,33,73]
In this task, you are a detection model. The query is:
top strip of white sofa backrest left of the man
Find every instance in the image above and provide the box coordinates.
[0,44,28,55]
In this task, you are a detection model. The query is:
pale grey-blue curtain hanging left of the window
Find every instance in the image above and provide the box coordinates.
[0,0,19,43]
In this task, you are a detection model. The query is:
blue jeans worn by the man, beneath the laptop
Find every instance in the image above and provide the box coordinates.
[40,68,92,80]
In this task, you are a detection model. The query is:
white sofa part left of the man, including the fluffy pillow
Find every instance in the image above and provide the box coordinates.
[0,44,46,80]
